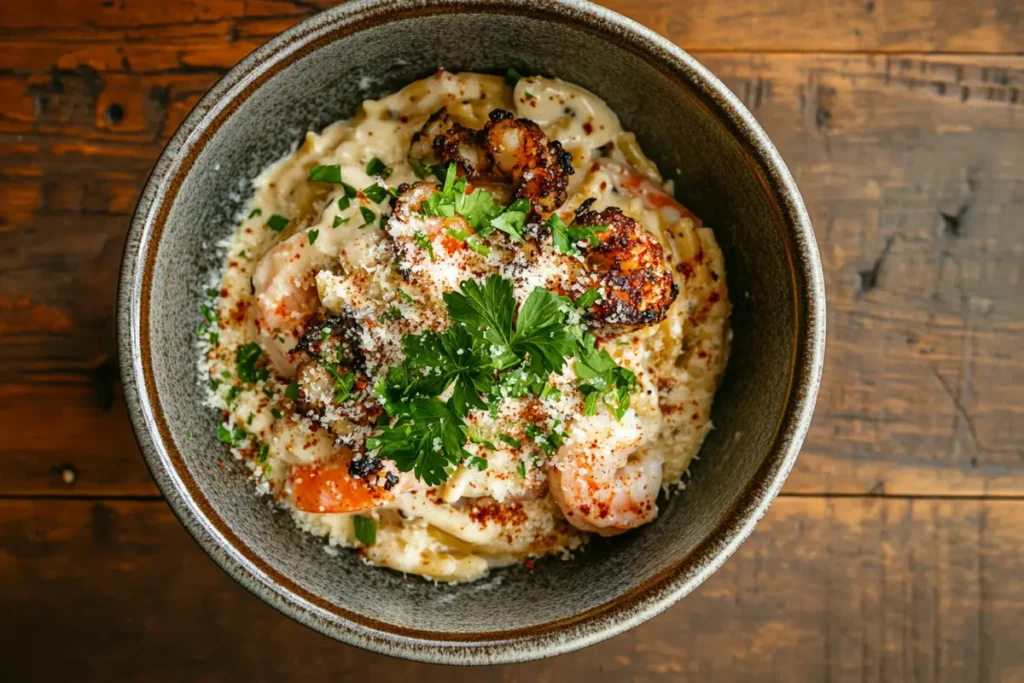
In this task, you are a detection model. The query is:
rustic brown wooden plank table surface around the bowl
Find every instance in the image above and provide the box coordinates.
[0,0,1024,683]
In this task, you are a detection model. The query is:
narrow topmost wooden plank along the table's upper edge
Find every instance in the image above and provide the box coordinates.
[0,0,1024,57]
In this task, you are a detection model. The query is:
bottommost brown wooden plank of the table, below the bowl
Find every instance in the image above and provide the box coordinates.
[0,498,1024,683]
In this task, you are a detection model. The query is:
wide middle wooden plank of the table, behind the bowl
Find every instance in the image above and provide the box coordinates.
[0,53,1024,496]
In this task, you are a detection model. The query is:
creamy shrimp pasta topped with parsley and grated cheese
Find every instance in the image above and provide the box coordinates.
[199,71,730,582]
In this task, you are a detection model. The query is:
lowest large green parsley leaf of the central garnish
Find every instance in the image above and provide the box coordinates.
[367,397,466,486]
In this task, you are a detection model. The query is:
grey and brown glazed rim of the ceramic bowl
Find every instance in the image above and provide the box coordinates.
[117,0,825,665]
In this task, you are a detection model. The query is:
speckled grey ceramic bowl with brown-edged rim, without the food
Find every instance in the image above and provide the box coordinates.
[118,0,824,664]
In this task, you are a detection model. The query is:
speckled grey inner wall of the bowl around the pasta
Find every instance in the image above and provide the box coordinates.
[141,1,800,655]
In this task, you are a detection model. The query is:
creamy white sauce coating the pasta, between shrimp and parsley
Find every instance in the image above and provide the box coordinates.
[200,72,729,582]
